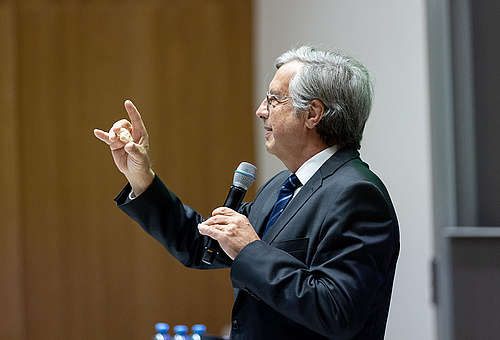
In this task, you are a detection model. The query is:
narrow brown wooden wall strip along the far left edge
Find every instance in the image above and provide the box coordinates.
[0,1,25,339]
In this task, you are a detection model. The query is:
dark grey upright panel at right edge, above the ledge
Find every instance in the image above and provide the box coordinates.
[470,0,500,226]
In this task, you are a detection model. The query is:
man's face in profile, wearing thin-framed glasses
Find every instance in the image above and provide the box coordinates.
[256,62,304,164]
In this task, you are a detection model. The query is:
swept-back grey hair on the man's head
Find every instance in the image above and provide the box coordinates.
[275,46,373,149]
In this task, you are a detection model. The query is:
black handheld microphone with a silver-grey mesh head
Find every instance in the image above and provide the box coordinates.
[201,162,257,265]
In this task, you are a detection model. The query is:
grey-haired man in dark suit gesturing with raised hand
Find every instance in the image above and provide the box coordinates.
[95,46,399,340]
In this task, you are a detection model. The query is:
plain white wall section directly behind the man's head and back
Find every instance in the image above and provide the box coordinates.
[254,0,437,340]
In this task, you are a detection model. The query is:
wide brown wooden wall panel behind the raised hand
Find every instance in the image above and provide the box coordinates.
[0,0,253,339]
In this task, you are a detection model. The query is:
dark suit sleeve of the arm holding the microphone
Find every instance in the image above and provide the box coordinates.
[231,182,399,339]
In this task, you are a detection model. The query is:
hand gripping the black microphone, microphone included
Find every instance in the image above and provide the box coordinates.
[198,162,259,265]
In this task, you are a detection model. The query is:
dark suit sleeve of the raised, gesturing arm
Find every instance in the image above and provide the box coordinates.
[115,176,232,269]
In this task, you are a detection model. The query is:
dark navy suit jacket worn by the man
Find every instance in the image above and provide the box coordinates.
[116,149,399,340]
